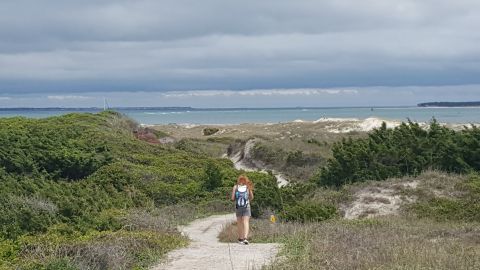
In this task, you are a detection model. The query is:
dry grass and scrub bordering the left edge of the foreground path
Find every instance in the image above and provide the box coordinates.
[15,200,231,269]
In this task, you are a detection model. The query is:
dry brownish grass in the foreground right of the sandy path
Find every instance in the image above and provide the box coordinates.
[220,217,480,269]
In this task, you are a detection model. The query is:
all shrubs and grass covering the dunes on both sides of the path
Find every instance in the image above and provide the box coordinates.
[0,111,480,269]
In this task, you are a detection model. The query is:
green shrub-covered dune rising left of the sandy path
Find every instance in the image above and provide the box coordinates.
[0,111,277,269]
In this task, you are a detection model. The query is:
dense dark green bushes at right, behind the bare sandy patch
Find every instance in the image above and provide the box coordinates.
[317,120,480,186]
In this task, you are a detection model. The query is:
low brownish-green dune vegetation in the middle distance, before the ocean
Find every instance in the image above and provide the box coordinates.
[155,122,366,182]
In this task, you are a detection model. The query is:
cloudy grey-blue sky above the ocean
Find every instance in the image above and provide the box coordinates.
[0,0,480,107]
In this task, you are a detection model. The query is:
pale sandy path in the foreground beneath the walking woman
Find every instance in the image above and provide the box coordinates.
[152,213,279,270]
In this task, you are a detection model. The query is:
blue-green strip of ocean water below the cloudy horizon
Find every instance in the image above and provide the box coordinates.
[0,107,480,125]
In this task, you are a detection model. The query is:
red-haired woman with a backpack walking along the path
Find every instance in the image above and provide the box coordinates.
[231,175,253,245]
